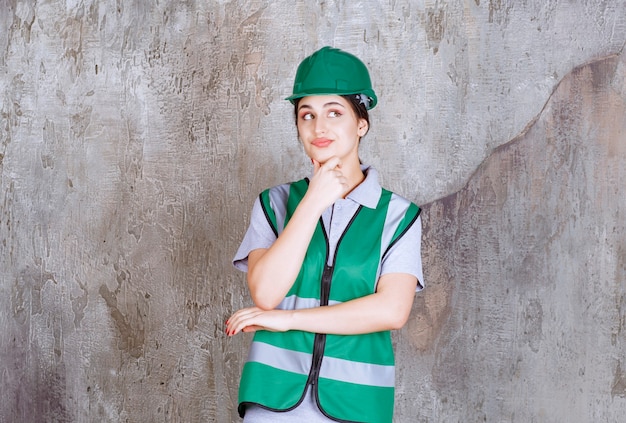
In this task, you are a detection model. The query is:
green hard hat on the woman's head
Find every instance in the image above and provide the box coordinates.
[285,47,378,110]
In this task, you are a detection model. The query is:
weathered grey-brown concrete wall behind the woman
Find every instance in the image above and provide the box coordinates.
[0,0,626,423]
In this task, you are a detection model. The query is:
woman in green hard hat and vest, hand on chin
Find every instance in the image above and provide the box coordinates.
[226,47,422,423]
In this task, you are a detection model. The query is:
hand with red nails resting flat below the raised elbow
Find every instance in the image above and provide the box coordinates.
[226,307,289,336]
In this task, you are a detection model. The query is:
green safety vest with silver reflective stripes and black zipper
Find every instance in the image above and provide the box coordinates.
[239,179,420,422]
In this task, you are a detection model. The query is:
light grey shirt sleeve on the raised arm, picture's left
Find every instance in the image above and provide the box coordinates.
[233,197,276,272]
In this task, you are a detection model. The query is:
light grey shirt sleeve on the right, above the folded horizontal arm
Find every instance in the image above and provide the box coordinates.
[380,216,425,291]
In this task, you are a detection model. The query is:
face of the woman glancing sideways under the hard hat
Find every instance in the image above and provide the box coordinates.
[297,95,368,163]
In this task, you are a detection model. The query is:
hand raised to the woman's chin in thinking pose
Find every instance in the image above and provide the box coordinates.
[305,157,350,214]
